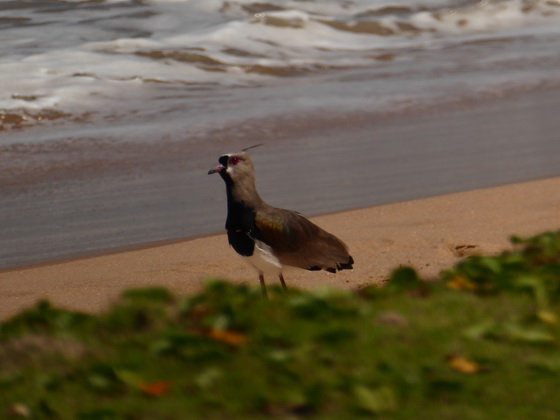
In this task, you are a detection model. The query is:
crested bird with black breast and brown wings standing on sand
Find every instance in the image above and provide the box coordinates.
[208,147,354,298]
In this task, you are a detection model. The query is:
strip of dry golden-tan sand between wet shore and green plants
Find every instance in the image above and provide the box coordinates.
[0,178,560,319]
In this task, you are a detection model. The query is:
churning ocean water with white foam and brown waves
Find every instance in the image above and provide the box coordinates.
[0,0,560,138]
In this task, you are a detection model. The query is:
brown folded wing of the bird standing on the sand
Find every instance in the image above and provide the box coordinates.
[255,206,354,272]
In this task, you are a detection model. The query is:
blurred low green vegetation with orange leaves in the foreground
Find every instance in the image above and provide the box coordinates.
[0,232,560,420]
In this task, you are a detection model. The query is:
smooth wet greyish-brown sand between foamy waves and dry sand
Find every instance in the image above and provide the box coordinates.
[0,88,560,269]
